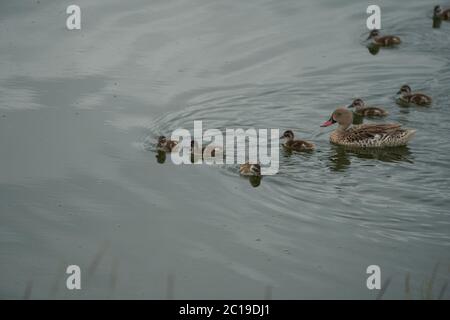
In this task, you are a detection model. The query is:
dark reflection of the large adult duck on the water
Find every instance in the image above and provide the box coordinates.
[329,145,414,171]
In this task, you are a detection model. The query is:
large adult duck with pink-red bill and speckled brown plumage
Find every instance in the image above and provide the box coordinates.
[321,108,416,148]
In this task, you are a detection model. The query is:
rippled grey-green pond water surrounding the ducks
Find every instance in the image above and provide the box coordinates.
[0,0,450,299]
